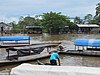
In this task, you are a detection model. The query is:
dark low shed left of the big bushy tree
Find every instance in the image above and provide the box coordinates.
[25,26,42,34]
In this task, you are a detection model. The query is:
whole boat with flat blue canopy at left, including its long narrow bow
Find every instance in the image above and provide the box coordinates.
[0,36,62,48]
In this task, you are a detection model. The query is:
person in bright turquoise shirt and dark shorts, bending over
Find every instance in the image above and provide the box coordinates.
[50,50,61,66]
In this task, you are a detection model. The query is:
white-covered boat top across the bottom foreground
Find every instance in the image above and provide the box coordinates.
[10,63,100,75]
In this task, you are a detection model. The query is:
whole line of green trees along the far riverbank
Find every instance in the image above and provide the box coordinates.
[10,3,100,34]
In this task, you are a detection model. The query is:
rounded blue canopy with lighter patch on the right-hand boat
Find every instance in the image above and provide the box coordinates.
[74,39,100,47]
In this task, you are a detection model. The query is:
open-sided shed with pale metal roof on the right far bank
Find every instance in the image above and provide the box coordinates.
[77,24,100,33]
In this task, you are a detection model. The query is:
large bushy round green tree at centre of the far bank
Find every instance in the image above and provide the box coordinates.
[41,11,69,34]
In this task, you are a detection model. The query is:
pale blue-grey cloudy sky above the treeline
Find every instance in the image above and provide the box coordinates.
[0,0,100,22]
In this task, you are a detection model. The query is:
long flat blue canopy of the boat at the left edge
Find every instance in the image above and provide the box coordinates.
[0,36,30,41]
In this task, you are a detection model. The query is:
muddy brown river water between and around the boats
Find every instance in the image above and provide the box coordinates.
[0,33,100,71]
